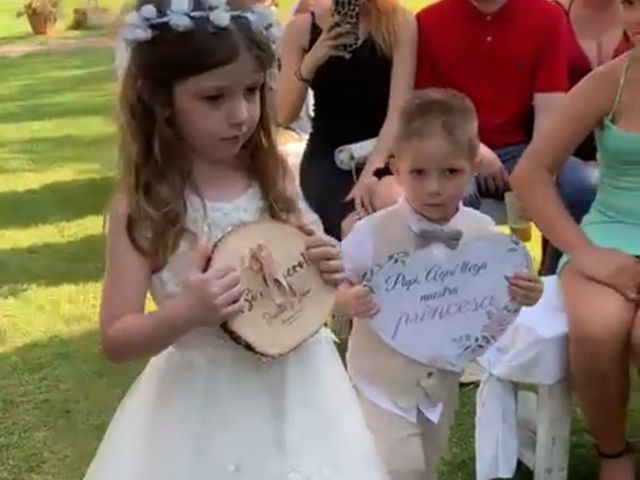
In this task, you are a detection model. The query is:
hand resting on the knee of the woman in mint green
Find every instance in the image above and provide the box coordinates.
[570,245,640,302]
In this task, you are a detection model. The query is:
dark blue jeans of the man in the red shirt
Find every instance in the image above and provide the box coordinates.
[464,143,597,275]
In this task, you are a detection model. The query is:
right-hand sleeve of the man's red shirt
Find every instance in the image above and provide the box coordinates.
[533,5,570,93]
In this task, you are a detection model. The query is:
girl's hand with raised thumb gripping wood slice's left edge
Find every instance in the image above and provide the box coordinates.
[180,245,243,327]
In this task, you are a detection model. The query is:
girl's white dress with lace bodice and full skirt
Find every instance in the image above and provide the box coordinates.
[85,187,388,480]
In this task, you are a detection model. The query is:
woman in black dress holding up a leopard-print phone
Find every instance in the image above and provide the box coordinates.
[277,0,417,239]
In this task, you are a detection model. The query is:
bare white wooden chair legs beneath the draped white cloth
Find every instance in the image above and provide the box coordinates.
[517,382,571,480]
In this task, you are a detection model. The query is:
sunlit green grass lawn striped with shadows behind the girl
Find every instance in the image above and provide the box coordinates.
[0,24,636,480]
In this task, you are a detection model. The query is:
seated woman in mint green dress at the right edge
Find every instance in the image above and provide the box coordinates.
[511,4,640,480]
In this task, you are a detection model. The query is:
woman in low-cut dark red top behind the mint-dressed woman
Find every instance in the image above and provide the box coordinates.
[556,0,633,162]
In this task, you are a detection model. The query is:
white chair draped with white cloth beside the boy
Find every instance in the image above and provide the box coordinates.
[476,276,572,480]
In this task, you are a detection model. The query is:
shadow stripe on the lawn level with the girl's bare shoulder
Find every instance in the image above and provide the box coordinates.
[0,176,113,229]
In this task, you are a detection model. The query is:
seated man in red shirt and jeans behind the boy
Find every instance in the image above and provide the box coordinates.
[415,0,596,270]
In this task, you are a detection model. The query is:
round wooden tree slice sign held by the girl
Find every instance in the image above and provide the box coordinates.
[211,220,335,358]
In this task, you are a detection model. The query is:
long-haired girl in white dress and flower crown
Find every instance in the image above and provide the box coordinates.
[85,0,387,480]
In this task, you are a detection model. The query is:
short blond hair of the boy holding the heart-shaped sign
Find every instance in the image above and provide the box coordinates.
[396,88,480,160]
